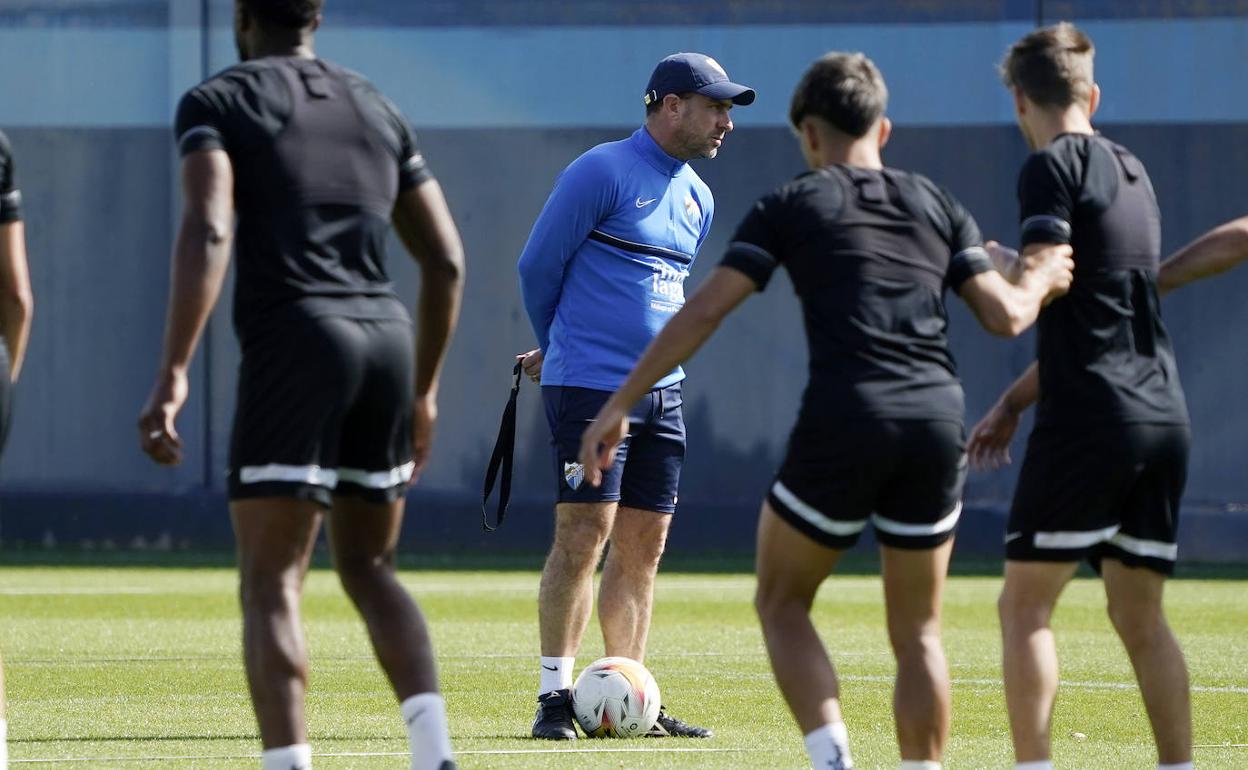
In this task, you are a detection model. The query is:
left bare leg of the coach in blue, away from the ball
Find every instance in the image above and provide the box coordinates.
[538,503,618,658]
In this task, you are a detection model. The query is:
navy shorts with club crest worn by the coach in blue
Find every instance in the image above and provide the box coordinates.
[542,382,685,513]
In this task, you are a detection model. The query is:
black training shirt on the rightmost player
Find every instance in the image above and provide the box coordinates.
[1018,134,1187,424]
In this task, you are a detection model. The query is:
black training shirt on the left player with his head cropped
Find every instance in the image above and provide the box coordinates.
[176,56,429,337]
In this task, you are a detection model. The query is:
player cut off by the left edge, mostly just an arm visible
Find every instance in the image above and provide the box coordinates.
[0,132,34,768]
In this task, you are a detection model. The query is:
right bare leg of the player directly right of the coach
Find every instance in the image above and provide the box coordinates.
[880,539,953,761]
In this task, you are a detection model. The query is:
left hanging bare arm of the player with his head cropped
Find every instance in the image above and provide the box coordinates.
[139,150,233,465]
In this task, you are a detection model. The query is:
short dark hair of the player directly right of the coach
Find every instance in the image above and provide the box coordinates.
[789,51,889,136]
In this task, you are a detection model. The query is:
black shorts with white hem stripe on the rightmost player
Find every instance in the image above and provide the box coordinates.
[1006,423,1191,575]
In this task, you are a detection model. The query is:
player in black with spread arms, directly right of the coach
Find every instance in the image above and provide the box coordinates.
[580,54,1071,768]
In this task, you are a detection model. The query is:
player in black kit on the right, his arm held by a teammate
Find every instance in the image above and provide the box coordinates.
[970,24,1192,769]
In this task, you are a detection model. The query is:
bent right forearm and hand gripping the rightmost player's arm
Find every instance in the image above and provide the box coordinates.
[957,243,1075,337]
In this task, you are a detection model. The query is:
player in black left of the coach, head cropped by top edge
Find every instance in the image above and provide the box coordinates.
[140,0,463,770]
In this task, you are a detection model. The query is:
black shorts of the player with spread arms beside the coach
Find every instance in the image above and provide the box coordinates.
[768,419,966,549]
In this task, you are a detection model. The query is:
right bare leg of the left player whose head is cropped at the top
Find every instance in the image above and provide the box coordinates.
[328,495,438,701]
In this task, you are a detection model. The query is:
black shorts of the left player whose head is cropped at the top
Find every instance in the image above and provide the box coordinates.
[230,316,416,505]
